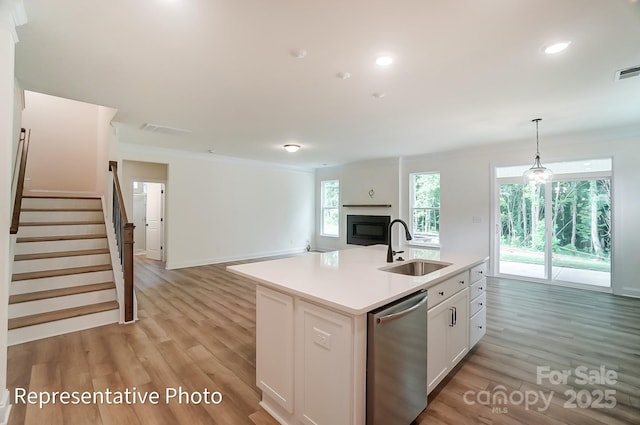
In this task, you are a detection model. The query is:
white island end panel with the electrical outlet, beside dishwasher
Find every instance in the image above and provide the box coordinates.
[296,301,354,425]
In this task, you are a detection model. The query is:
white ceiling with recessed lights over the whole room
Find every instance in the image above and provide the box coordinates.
[16,0,640,168]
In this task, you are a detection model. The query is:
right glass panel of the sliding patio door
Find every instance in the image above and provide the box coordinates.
[551,178,611,287]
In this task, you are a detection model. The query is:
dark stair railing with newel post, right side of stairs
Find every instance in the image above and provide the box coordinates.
[109,161,136,322]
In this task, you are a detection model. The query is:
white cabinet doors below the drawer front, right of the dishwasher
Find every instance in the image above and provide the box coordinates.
[427,288,469,392]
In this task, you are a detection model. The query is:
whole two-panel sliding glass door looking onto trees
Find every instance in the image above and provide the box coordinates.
[496,160,612,287]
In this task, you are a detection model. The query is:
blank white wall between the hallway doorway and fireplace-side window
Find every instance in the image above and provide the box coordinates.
[120,143,315,269]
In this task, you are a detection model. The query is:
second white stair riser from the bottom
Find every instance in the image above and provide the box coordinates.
[8,289,116,319]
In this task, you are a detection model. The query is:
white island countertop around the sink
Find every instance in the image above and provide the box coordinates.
[227,245,487,315]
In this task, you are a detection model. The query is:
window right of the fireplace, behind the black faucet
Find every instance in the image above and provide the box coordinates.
[409,173,440,246]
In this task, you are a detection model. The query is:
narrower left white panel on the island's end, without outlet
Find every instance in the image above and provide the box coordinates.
[256,286,294,413]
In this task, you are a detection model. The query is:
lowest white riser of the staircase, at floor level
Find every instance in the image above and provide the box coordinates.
[7,310,120,345]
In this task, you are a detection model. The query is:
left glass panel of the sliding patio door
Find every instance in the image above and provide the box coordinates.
[498,183,549,279]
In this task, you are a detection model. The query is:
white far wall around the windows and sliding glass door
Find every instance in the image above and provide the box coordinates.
[316,128,640,297]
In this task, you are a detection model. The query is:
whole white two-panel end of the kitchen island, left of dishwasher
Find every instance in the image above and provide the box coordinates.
[256,285,366,425]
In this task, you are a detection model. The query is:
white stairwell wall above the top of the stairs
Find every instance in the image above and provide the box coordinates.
[22,91,115,196]
